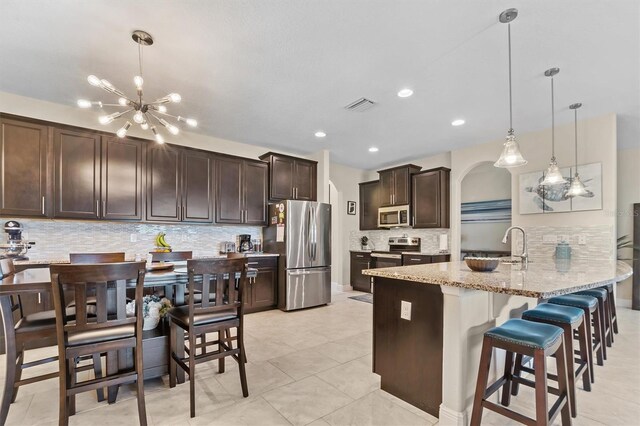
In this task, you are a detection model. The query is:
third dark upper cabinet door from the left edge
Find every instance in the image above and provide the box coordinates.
[101,136,144,220]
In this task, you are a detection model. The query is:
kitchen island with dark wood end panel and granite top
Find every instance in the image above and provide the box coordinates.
[363,260,632,425]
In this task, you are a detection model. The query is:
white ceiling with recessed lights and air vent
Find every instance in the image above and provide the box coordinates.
[0,0,640,169]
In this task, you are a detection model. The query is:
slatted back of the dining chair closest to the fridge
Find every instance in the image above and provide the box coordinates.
[187,257,247,324]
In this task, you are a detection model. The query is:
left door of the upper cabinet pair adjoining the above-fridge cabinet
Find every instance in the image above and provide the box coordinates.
[215,157,244,223]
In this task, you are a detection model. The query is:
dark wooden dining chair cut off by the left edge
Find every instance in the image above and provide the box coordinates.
[0,258,104,425]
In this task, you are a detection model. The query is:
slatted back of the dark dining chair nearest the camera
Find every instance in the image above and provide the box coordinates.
[49,262,146,346]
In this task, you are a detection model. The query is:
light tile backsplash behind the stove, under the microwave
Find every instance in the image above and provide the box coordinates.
[349,228,451,253]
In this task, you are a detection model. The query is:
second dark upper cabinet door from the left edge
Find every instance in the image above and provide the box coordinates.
[53,129,100,219]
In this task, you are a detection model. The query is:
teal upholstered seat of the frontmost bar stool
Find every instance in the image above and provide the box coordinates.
[484,319,563,349]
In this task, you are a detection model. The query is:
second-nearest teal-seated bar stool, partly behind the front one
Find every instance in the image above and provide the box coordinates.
[511,303,591,417]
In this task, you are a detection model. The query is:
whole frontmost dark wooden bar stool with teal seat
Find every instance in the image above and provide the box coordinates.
[471,319,571,426]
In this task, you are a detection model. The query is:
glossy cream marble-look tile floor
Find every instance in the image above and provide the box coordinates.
[0,292,640,426]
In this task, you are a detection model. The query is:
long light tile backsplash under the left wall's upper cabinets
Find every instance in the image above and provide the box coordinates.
[7,218,262,260]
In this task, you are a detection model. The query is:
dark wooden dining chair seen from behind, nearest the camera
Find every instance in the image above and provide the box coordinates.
[50,262,147,425]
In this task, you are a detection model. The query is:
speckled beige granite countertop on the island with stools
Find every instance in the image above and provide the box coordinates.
[362,260,633,299]
